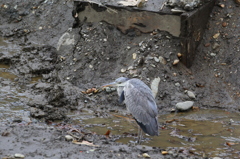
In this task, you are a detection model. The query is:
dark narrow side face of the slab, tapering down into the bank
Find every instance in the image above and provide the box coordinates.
[180,0,216,68]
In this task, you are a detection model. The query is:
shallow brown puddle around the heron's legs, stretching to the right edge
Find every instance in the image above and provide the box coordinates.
[79,109,240,158]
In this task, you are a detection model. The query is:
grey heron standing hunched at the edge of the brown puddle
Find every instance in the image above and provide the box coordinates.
[102,77,159,143]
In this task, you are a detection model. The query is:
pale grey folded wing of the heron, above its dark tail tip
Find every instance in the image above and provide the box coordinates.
[124,80,158,125]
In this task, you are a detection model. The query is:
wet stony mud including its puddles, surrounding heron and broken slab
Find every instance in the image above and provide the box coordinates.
[0,0,240,158]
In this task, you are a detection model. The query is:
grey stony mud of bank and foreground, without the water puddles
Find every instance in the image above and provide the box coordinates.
[0,0,240,158]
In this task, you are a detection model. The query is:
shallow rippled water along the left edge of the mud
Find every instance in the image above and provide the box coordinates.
[0,41,29,125]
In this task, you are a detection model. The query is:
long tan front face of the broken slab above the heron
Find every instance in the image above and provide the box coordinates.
[73,1,181,37]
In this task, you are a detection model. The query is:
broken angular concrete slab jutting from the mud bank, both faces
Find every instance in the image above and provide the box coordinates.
[73,0,216,67]
